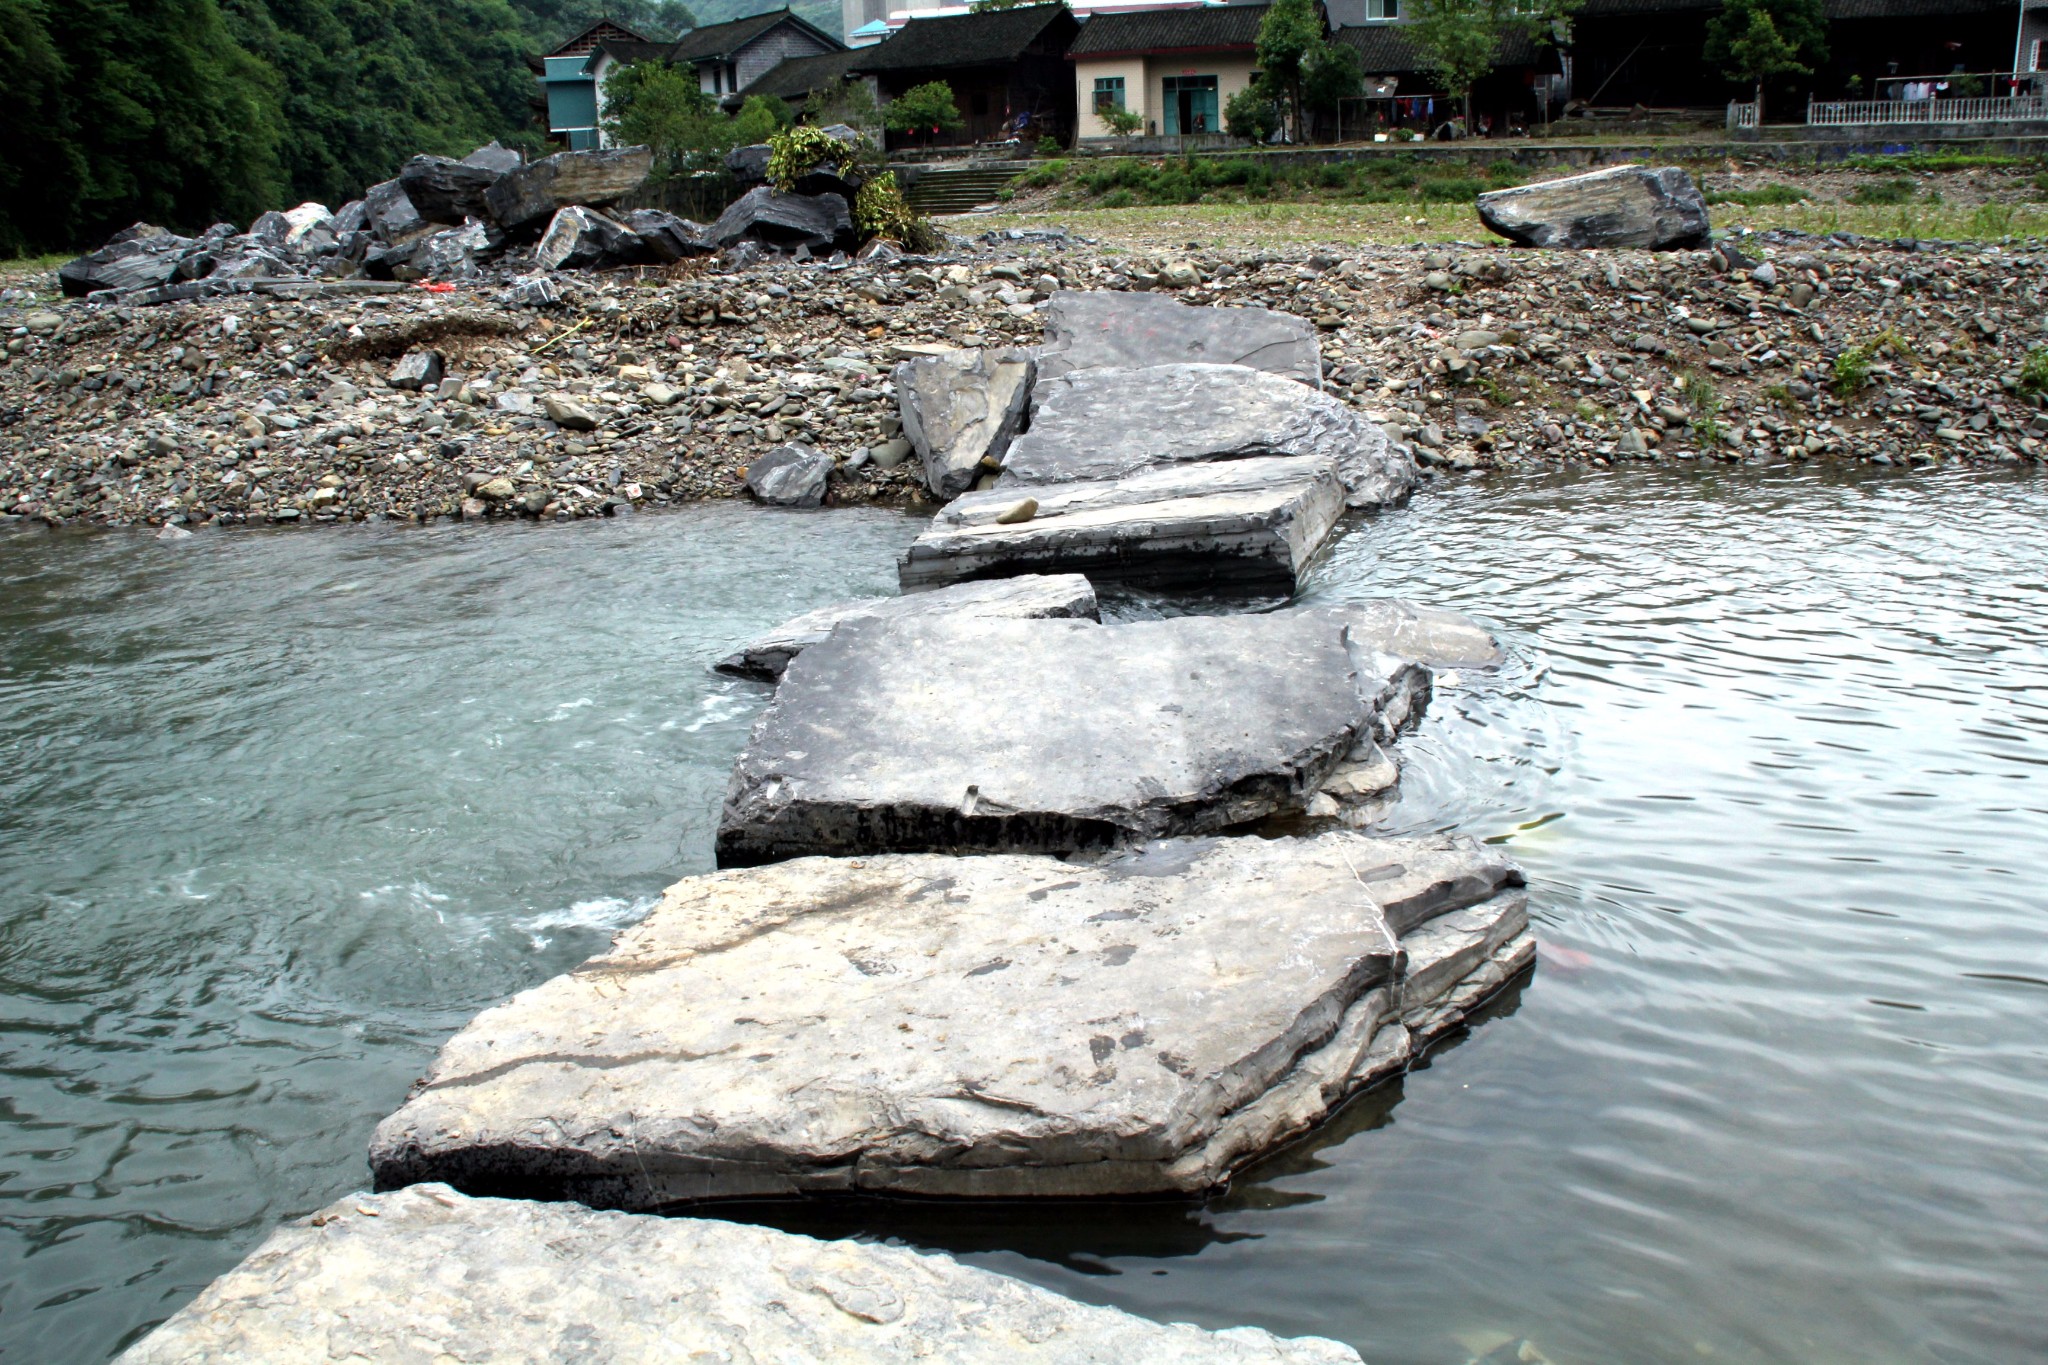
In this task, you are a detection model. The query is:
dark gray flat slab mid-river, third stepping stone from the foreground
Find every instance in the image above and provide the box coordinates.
[719,612,1427,868]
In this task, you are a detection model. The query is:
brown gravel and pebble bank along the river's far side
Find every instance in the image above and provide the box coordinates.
[0,223,2048,528]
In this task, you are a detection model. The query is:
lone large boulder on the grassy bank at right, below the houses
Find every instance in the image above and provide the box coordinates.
[1477,166,1708,250]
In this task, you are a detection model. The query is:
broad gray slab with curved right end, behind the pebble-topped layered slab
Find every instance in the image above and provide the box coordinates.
[999,364,1415,508]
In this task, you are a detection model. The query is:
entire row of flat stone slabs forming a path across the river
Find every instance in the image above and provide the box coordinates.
[112,295,1534,1365]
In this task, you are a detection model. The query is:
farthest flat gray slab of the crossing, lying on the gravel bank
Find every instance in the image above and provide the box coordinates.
[1038,289,1323,389]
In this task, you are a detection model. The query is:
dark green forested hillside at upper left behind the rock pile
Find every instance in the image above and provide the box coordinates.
[0,0,696,254]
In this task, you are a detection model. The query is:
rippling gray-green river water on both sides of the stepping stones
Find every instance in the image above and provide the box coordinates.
[0,471,2048,1365]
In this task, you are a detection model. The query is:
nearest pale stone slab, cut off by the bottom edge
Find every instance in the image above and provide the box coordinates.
[121,1185,1358,1365]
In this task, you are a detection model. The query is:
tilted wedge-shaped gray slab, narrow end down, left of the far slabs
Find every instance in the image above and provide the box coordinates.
[891,350,1036,497]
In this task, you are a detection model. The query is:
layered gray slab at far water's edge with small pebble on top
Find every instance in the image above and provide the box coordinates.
[897,456,1343,591]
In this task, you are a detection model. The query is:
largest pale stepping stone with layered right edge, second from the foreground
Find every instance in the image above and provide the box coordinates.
[371,834,1534,1209]
